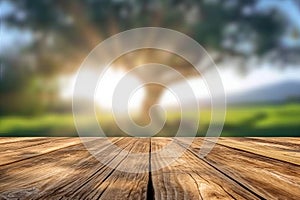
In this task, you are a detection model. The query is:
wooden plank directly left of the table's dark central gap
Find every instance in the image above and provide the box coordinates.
[39,138,149,199]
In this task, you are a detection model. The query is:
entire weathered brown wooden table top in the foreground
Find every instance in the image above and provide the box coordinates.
[0,137,300,199]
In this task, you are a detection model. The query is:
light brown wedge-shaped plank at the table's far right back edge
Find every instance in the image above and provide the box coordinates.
[212,138,300,165]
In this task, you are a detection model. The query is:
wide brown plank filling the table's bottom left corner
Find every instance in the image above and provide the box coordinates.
[0,138,120,199]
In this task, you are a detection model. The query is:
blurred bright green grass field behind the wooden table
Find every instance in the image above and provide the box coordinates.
[0,104,300,136]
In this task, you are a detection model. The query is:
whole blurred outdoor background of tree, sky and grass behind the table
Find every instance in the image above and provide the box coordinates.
[0,0,300,136]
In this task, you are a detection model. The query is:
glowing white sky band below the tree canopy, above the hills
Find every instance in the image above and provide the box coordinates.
[60,66,300,110]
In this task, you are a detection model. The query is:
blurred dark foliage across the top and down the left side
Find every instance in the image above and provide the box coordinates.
[0,0,299,114]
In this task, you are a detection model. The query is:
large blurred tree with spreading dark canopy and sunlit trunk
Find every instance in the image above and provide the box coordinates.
[5,0,298,121]
